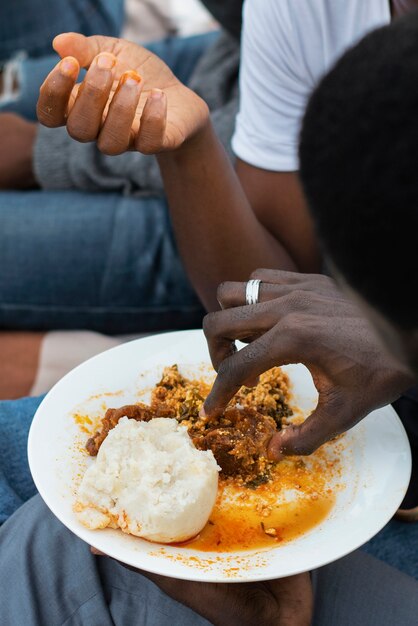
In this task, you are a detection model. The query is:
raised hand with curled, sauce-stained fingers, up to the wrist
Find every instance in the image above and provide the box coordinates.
[37,33,208,155]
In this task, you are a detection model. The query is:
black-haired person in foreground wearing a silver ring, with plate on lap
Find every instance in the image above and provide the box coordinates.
[0,9,418,626]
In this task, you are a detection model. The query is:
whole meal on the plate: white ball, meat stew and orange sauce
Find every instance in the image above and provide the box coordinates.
[74,365,340,552]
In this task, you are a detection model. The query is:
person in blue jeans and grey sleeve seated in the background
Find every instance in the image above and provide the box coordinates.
[0,0,242,334]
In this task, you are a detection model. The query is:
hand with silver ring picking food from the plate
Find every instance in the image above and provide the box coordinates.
[204,270,412,460]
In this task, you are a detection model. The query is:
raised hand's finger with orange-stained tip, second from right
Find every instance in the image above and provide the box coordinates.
[97,71,143,155]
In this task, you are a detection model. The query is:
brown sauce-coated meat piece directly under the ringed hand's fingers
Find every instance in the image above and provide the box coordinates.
[193,407,277,479]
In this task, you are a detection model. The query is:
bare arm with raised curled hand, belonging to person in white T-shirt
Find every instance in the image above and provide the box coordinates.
[37,33,318,310]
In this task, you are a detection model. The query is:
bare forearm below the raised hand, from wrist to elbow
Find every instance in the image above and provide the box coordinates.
[158,124,296,311]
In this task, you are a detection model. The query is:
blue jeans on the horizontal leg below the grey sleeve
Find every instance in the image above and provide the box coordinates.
[0,33,217,333]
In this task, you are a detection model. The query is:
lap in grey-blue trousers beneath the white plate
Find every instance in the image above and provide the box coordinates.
[0,496,418,626]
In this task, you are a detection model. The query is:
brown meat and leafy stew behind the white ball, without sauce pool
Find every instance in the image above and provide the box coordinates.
[86,365,292,482]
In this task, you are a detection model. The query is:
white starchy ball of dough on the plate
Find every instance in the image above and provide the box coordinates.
[74,417,219,543]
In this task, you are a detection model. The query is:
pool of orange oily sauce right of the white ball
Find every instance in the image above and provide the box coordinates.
[175,459,335,552]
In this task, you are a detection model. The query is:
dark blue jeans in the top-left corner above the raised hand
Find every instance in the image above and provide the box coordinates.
[0,0,124,62]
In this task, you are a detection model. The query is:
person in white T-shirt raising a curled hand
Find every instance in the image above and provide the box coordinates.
[31,0,418,519]
